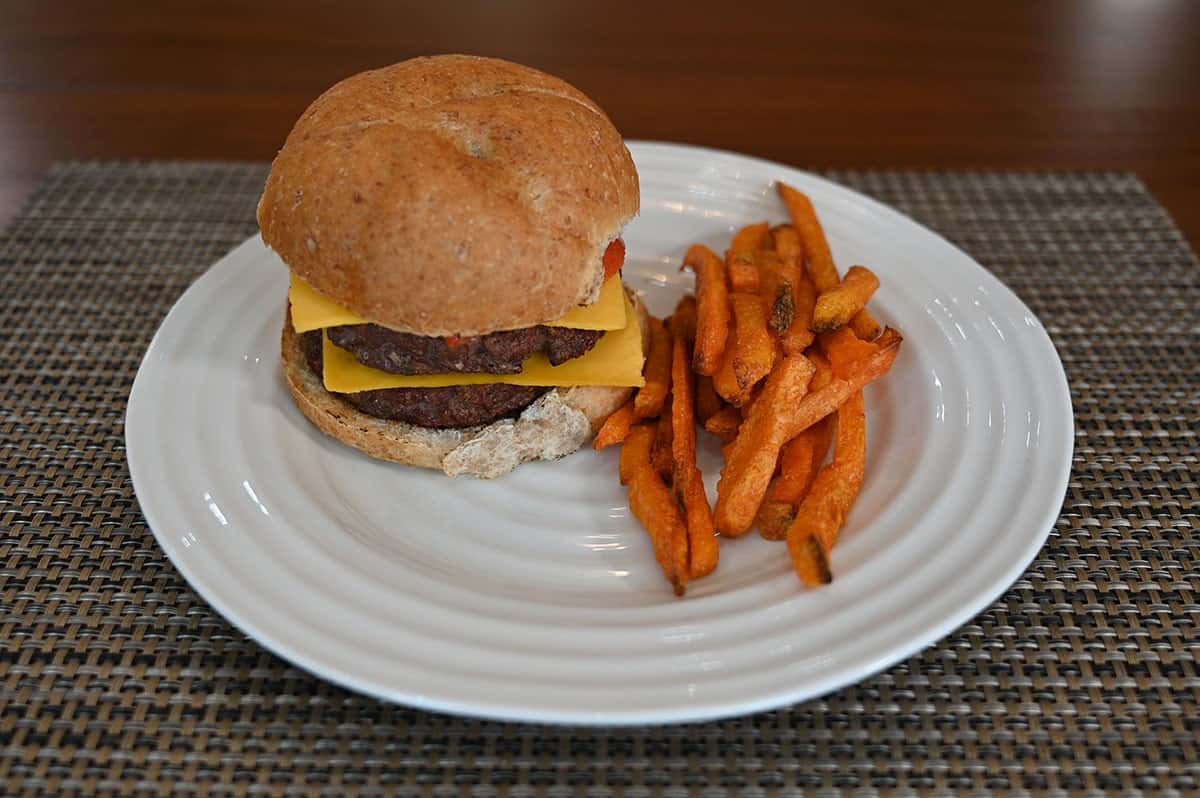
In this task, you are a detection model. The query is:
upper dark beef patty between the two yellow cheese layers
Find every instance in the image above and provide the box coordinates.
[329,324,604,374]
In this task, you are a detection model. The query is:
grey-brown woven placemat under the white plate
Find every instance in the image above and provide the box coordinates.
[0,163,1200,798]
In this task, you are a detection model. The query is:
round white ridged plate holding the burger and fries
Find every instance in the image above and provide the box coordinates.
[126,143,1073,724]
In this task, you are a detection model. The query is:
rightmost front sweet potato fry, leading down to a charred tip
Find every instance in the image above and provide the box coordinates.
[787,389,866,566]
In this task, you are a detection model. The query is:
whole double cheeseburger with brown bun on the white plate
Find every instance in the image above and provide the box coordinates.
[258,55,644,478]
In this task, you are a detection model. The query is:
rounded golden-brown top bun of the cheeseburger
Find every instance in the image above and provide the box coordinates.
[258,55,638,335]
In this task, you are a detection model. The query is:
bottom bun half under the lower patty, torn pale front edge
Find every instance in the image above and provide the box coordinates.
[282,294,646,479]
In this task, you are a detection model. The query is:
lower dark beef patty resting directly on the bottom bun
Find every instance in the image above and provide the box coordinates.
[300,325,550,427]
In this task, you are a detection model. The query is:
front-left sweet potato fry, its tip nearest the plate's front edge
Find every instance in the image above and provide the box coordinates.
[620,424,689,595]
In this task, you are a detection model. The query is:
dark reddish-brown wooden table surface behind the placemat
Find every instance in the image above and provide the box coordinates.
[0,0,1200,247]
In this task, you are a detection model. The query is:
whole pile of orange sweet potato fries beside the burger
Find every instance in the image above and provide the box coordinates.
[594,182,901,595]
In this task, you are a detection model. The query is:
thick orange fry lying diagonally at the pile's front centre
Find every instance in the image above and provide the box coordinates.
[713,355,816,536]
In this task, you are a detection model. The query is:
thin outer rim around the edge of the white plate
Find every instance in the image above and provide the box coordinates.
[124,140,1074,726]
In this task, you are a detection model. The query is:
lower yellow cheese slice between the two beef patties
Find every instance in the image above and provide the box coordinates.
[323,292,646,394]
